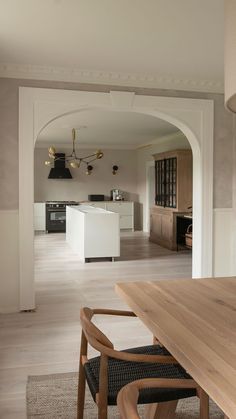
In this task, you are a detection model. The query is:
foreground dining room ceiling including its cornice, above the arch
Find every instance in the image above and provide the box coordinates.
[0,0,224,91]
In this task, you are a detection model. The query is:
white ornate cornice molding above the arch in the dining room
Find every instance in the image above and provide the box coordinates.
[0,63,224,93]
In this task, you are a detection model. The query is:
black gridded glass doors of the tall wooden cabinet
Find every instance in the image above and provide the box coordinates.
[155,157,177,208]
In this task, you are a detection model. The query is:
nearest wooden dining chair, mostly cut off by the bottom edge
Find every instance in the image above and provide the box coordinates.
[117,378,209,419]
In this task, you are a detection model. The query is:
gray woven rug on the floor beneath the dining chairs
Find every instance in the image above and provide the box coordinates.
[27,373,224,419]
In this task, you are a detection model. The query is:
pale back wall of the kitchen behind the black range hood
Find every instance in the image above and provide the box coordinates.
[34,147,139,202]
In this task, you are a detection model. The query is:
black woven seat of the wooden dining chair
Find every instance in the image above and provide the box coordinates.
[84,345,196,405]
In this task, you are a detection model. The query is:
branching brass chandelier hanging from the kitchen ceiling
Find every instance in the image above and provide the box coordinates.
[45,128,103,175]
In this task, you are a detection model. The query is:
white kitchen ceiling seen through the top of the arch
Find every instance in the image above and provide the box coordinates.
[36,110,178,151]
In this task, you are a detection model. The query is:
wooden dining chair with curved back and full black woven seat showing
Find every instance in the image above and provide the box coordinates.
[77,307,206,419]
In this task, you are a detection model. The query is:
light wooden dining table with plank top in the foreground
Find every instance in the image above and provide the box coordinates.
[116,277,236,419]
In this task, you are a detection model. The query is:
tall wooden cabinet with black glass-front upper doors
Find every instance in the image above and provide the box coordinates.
[150,150,192,250]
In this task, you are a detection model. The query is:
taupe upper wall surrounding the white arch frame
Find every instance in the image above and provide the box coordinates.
[0,78,234,209]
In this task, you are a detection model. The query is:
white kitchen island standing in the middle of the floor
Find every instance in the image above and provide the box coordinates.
[66,205,120,262]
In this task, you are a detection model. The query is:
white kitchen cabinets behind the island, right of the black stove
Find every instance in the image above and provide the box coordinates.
[87,201,134,231]
